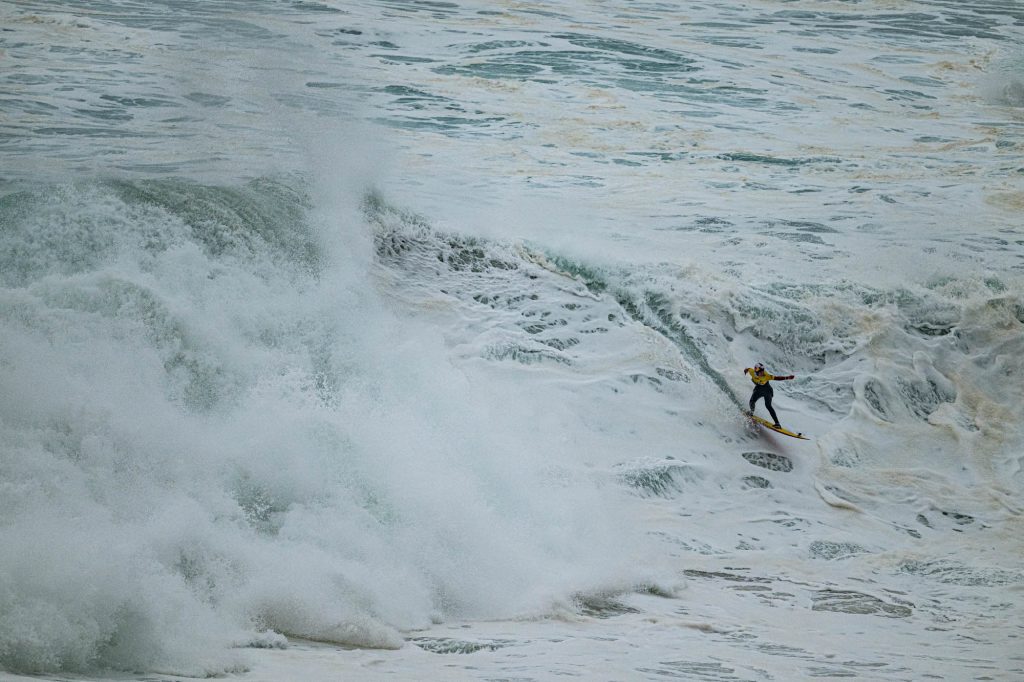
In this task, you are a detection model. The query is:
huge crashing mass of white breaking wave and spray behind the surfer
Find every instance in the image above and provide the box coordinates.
[0,180,655,674]
